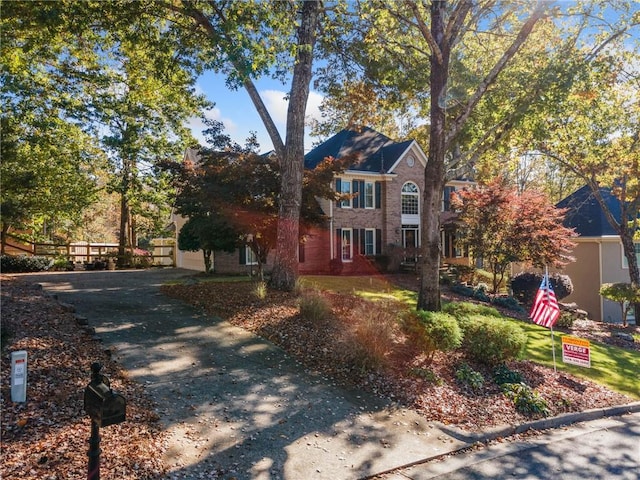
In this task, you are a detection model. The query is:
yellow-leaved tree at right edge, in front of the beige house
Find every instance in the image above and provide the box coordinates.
[536,33,640,314]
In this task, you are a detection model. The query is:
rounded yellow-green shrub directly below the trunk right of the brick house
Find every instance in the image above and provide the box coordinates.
[405,310,462,363]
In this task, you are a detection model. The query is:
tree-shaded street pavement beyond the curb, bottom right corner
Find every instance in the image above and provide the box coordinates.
[380,413,640,480]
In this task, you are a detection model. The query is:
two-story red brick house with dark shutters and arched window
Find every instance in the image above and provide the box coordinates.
[176,128,472,273]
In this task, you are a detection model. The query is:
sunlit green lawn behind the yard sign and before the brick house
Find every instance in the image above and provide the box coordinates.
[301,275,640,399]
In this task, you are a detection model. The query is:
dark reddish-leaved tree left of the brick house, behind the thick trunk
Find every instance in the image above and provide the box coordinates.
[162,121,348,275]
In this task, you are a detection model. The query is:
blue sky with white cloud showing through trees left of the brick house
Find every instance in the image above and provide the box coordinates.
[189,72,322,152]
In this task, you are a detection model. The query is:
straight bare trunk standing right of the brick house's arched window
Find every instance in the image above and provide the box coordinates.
[417,1,450,311]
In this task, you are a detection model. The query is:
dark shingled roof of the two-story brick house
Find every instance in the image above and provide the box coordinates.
[304,127,413,173]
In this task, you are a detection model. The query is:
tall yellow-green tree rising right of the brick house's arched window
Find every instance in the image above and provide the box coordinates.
[323,0,629,310]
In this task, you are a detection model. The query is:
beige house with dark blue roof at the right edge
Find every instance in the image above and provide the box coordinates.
[557,185,640,323]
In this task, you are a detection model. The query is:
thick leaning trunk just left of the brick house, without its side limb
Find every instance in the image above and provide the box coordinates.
[271,0,320,291]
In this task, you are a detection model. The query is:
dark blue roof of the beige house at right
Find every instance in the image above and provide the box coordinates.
[556,185,621,237]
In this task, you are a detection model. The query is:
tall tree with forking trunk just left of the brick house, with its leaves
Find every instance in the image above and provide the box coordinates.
[143,0,321,290]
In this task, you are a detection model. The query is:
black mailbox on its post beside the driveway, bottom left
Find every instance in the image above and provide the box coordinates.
[84,363,127,480]
